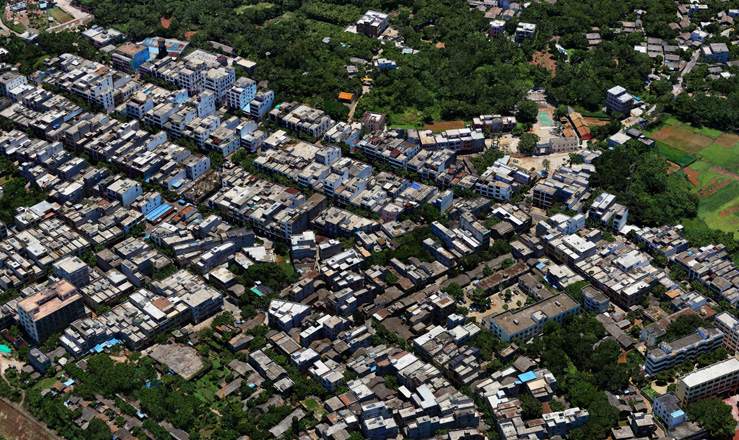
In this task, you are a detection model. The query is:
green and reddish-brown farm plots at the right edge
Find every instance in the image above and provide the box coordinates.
[647,118,739,238]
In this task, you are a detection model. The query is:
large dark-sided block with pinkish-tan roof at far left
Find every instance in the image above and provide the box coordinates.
[18,280,85,342]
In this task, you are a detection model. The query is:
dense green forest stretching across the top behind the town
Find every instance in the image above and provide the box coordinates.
[63,0,692,124]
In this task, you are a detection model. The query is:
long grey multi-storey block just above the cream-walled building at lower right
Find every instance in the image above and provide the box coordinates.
[644,327,724,375]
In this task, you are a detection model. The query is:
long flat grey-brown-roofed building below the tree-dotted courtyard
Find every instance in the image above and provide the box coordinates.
[483,293,580,342]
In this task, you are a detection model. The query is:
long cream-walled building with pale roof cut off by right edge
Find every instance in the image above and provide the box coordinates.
[675,358,739,408]
